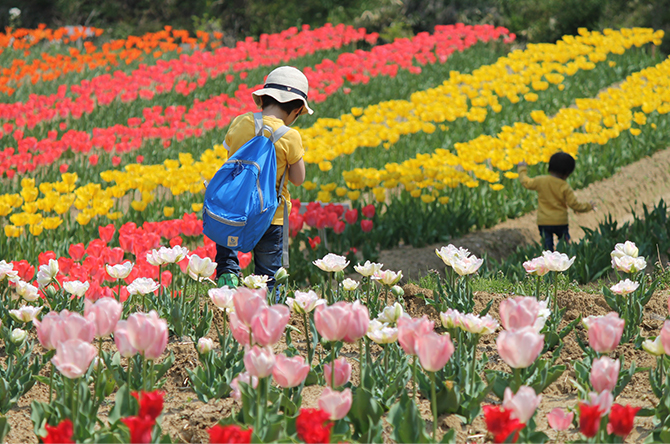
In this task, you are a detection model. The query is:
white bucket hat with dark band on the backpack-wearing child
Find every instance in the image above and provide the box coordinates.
[251,66,314,114]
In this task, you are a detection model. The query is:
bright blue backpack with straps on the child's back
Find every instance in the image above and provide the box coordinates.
[202,113,289,267]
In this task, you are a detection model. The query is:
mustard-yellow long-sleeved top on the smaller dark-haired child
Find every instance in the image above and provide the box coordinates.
[518,166,591,225]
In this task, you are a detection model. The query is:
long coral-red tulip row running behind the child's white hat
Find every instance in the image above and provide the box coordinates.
[0,26,514,178]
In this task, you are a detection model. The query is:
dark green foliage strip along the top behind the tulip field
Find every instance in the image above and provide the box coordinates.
[0,0,670,54]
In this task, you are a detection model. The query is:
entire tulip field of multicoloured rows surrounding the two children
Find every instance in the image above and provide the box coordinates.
[0,24,670,443]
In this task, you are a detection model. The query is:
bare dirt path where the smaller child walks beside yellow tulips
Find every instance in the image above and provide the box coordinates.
[379,148,670,279]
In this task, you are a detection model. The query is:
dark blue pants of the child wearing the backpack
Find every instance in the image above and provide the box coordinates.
[216,225,283,292]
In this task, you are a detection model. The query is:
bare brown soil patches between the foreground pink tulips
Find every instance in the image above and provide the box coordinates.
[7,284,670,443]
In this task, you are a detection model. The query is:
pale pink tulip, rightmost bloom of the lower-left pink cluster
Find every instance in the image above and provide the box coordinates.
[126,310,168,359]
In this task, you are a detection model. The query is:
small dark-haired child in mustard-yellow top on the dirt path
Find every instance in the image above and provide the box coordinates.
[517,152,596,251]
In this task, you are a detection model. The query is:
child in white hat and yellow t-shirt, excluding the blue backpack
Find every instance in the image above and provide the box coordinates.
[216,66,313,291]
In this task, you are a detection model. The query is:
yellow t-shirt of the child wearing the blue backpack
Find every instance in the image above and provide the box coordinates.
[224,113,305,225]
